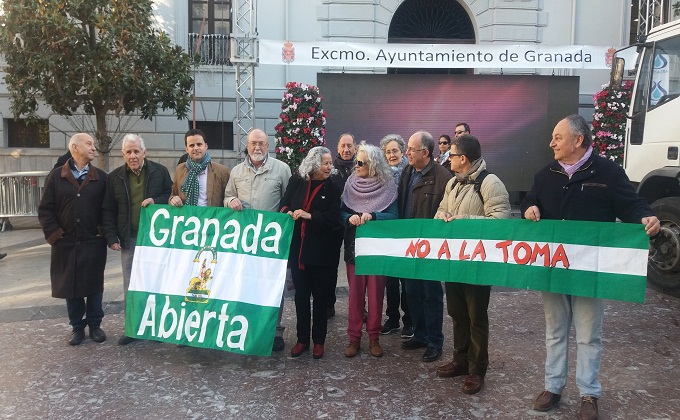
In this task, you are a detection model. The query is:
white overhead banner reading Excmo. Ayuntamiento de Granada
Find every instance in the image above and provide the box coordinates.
[258,39,636,69]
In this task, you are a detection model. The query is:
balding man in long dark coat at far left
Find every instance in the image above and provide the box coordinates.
[38,133,106,346]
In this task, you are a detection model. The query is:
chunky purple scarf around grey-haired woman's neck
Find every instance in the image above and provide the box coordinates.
[342,173,397,213]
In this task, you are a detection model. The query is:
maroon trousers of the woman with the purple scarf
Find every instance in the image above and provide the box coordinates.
[347,263,385,341]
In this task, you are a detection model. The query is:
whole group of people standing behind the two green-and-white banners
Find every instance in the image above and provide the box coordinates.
[39,114,659,419]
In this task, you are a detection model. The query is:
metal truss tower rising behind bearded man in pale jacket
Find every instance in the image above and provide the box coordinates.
[229,0,259,160]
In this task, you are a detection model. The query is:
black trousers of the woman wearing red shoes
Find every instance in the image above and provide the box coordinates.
[290,265,338,344]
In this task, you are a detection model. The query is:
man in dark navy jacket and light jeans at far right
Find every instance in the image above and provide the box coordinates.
[521,114,659,419]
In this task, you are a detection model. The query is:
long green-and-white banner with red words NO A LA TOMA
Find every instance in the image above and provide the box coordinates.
[356,219,649,302]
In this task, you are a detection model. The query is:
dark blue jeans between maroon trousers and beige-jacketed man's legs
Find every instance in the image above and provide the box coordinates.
[404,279,444,349]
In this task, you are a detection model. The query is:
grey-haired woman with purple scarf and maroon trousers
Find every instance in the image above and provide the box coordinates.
[340,142,398,357]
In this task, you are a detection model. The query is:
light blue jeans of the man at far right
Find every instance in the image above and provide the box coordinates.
[543,292,604,398]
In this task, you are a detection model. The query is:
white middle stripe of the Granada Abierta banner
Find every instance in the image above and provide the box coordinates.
[129,246,287,307]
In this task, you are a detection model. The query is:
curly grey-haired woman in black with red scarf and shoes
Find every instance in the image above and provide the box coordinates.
[281,146,343,359]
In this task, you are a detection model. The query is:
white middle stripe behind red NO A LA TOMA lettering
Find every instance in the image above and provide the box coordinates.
[356,238,649,276]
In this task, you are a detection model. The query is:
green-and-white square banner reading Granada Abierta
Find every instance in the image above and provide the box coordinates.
[125,205,293,356]
